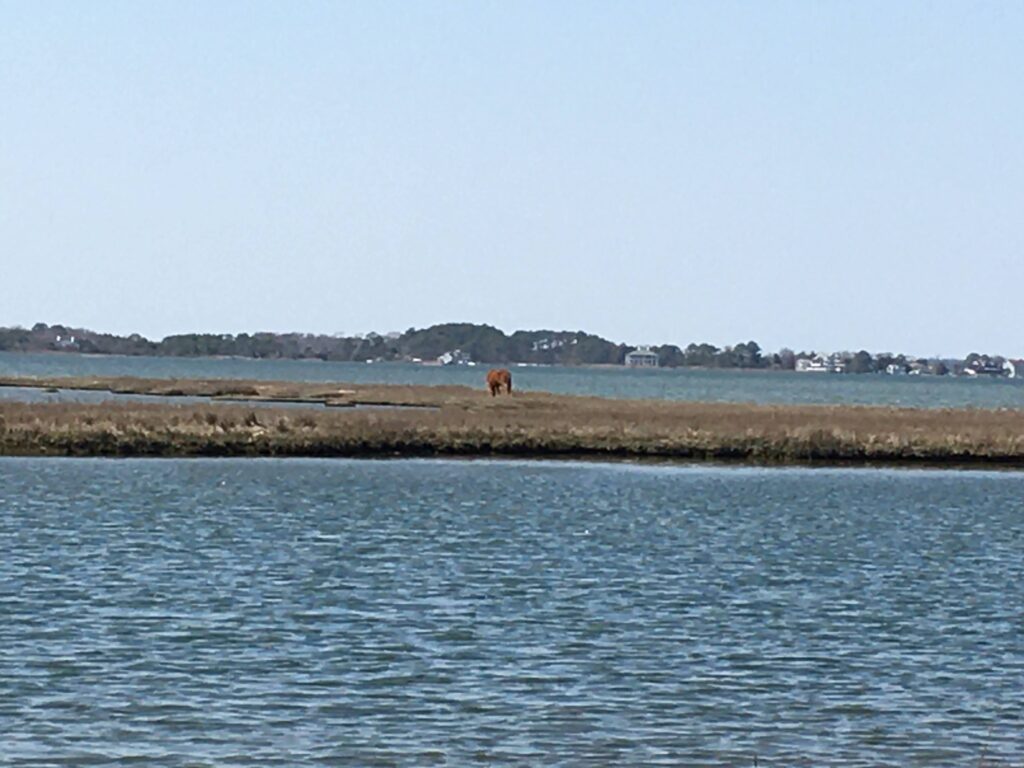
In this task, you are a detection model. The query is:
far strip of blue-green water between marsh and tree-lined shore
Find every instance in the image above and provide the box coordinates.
[0,352,1024,409]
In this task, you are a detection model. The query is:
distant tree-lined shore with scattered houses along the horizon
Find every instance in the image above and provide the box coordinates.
[0,323,1024,378]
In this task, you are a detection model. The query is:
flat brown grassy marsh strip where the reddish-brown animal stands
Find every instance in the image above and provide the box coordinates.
[0,378,1024,467]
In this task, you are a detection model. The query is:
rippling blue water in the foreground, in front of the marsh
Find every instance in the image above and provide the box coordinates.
[0,459,1024,766]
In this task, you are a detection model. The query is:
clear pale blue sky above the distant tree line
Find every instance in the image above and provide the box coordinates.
[0,0,1024,356]
